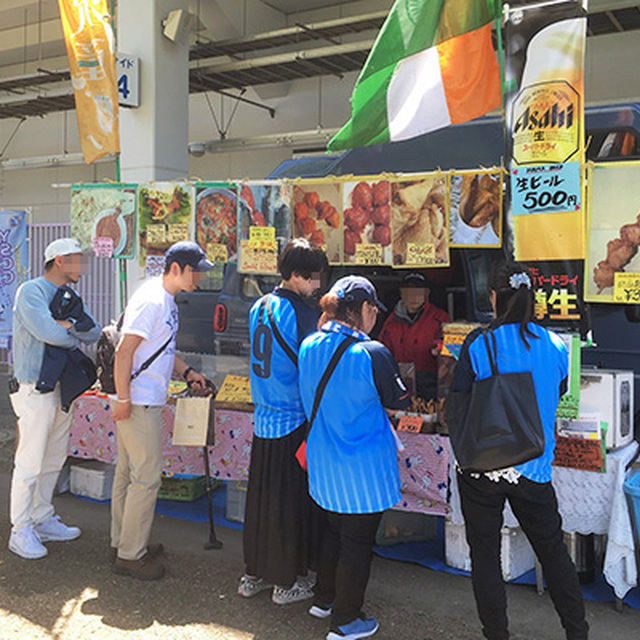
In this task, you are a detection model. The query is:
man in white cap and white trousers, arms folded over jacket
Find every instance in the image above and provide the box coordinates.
[9,238,100,560]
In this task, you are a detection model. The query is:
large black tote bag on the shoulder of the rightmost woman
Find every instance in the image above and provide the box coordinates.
[445,332,544,473]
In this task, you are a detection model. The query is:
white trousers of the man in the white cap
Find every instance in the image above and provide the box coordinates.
[9,383,72,529]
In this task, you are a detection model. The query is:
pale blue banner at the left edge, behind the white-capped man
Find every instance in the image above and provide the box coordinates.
[0,210,29,347]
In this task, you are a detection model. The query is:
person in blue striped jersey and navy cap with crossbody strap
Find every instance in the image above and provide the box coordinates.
[299,276,410,640]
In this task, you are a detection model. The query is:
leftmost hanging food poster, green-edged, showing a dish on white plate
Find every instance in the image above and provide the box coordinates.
[70,184,137,258]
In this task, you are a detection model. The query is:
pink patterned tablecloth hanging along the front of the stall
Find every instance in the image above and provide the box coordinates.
[69,396,449,515]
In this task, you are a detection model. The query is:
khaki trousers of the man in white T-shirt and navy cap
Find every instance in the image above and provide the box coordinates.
[111,403,162,560]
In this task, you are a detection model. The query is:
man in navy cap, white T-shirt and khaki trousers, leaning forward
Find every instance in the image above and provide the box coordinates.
[111,241,213,580]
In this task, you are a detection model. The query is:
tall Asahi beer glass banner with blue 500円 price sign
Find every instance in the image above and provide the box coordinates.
[505,1,587,260]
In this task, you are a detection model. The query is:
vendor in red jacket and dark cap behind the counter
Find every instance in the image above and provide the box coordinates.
[378,271,449,400]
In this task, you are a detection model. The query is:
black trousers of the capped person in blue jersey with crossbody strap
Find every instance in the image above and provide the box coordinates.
[316,511,382,629]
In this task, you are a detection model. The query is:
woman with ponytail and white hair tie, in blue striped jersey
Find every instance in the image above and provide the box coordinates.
[451,262,589,640]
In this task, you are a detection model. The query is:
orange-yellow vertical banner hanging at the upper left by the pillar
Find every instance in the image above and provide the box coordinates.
[58,0,120,164]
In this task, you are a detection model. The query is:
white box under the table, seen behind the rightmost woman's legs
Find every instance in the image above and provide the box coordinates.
[444,521,535,581]
